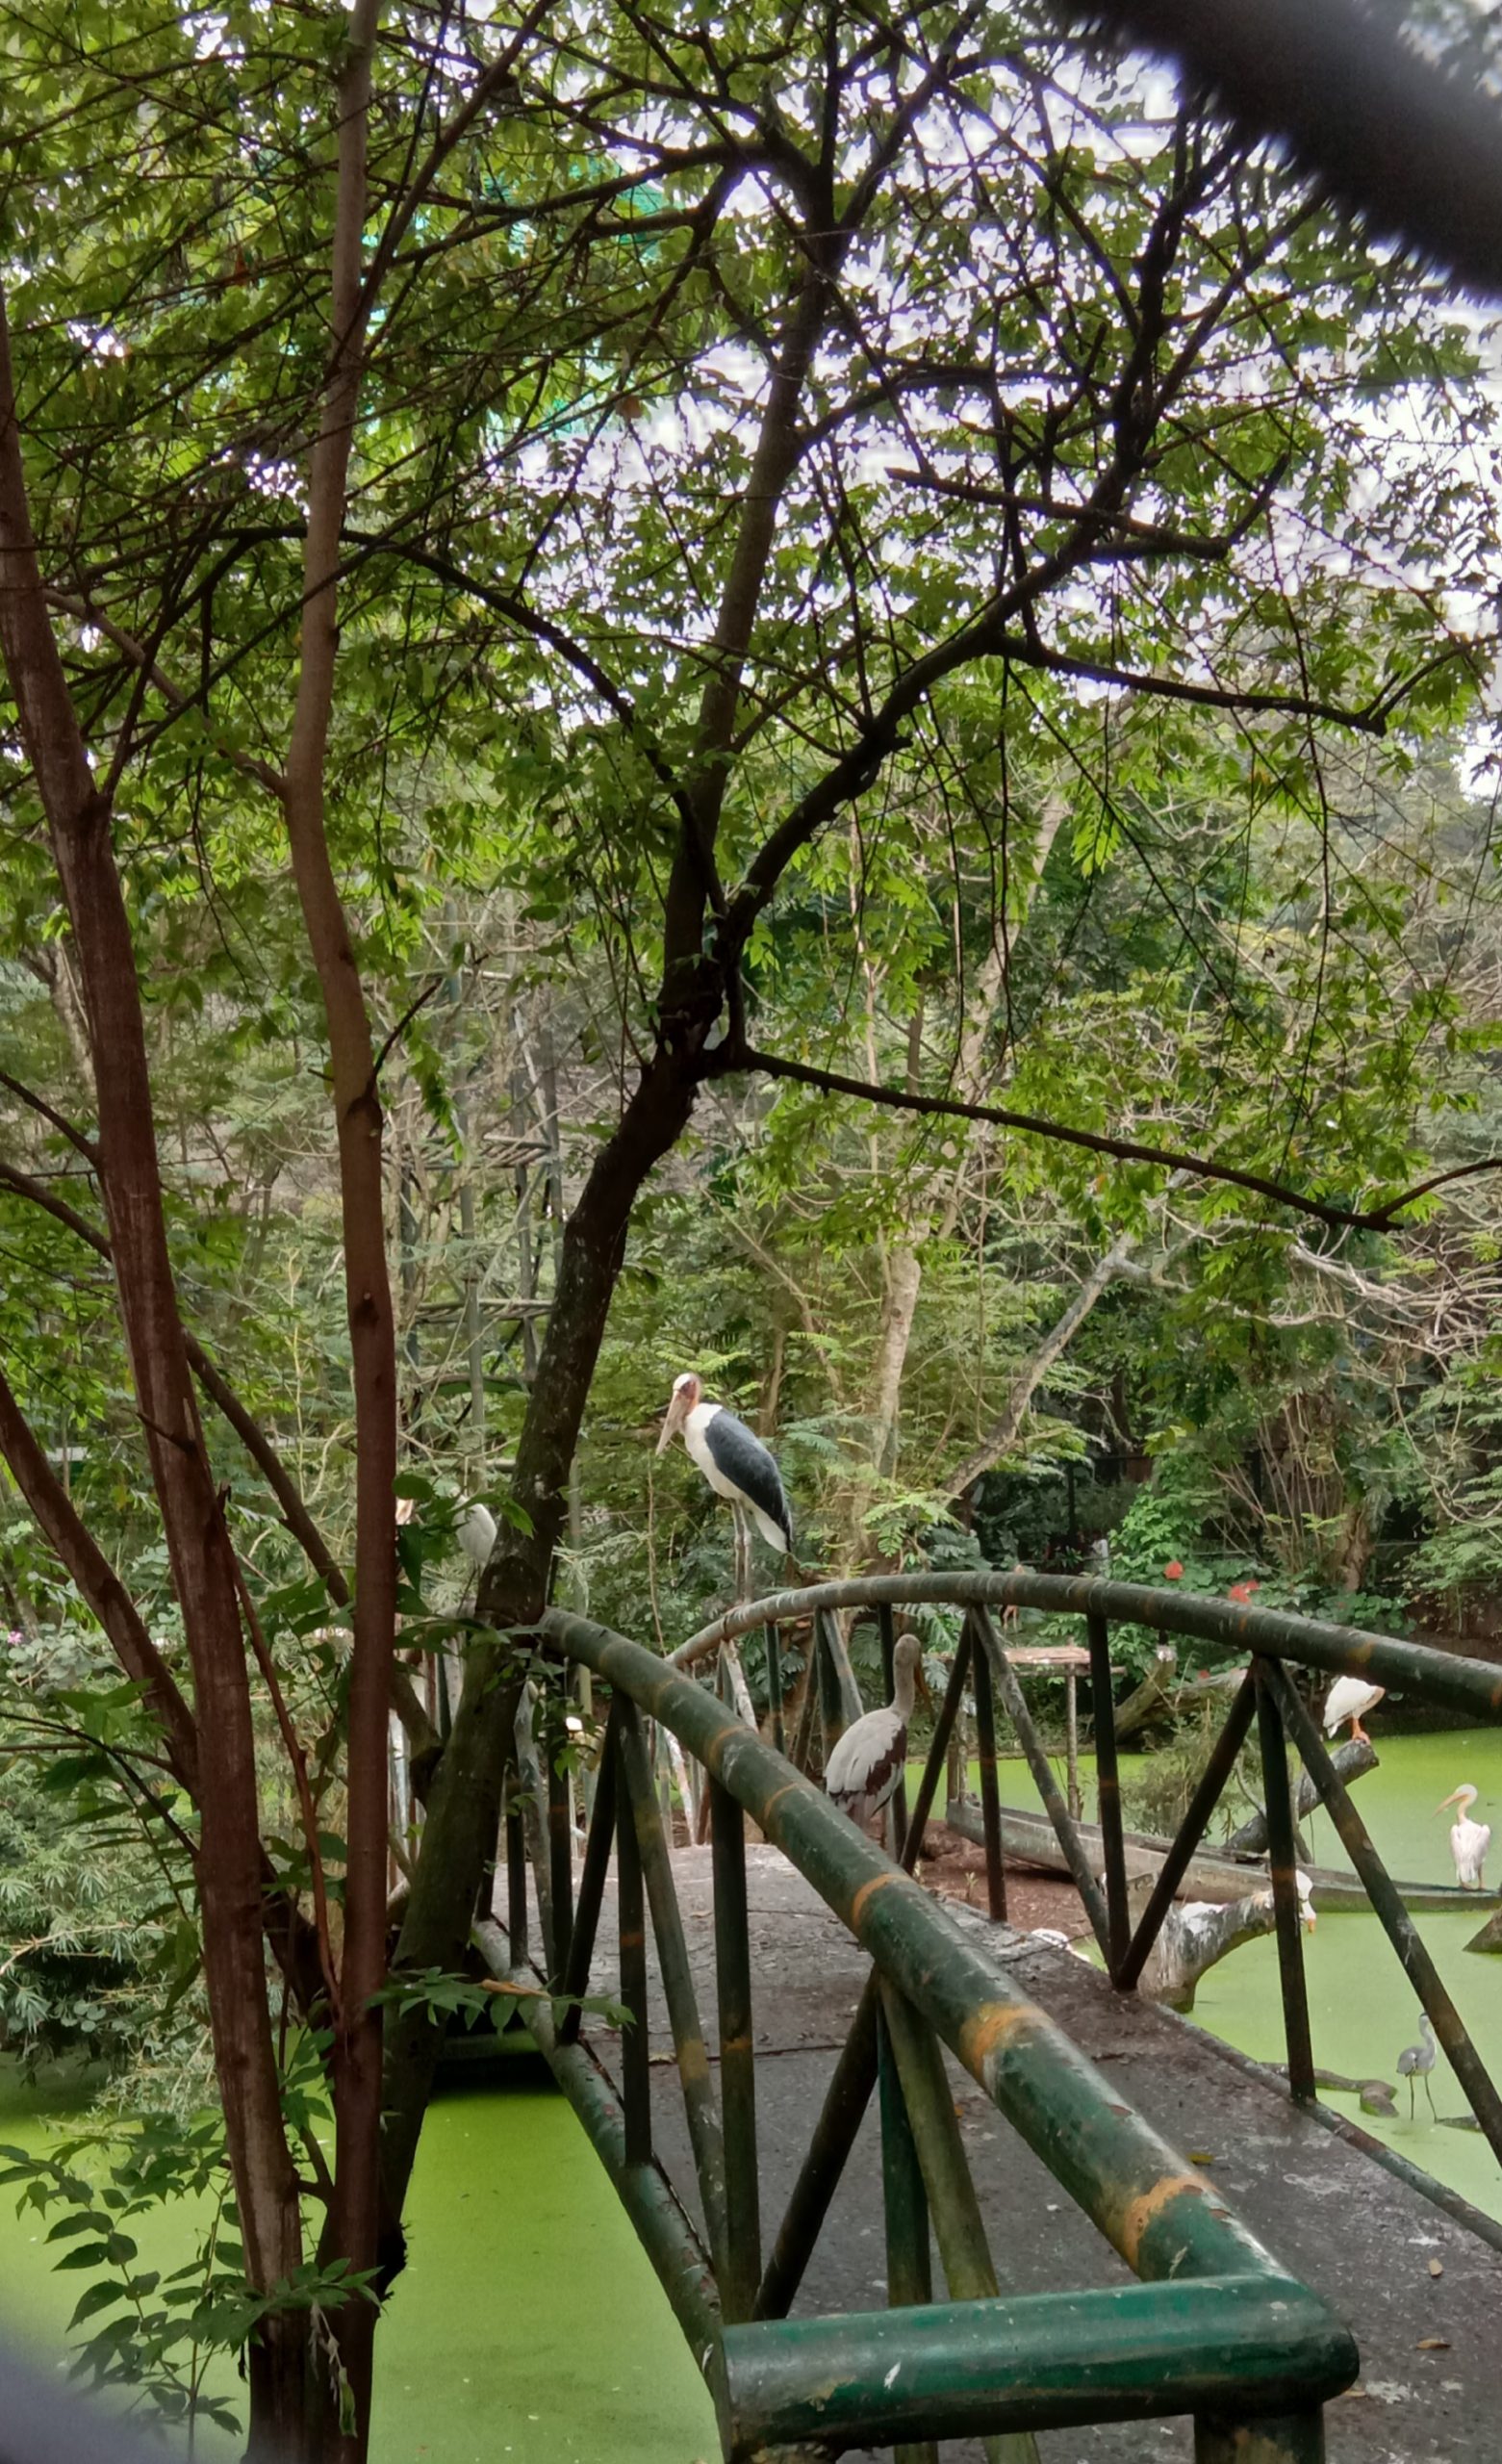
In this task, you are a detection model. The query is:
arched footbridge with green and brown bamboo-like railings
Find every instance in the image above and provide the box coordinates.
[480,1575,1502,2464]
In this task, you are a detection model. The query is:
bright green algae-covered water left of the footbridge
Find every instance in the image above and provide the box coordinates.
[0,2065,719,2464]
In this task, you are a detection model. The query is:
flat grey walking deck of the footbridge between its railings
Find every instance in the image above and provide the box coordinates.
[541,1845,1502,2464]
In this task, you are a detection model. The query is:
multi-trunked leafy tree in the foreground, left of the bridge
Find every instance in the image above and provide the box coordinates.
[0,0,1488,2459]
